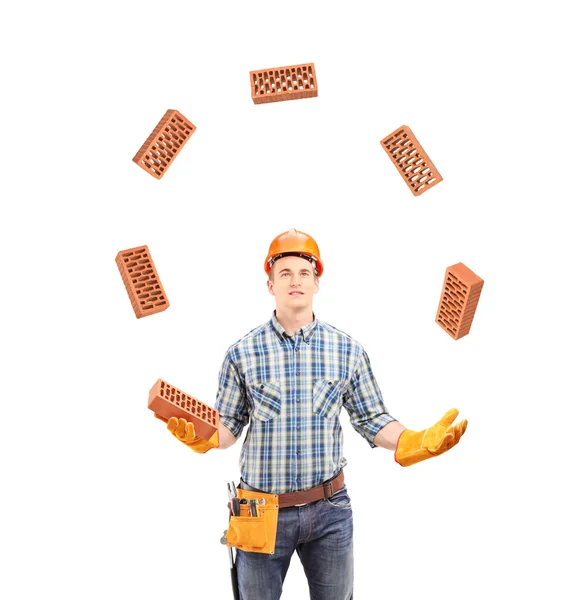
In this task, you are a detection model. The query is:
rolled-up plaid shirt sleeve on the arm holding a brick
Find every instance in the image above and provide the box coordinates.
[215,352,249,438]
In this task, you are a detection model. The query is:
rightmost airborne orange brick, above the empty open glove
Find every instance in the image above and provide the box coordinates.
[436,263,485,340]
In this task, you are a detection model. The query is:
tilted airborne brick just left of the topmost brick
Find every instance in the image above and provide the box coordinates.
[132,109,196,179]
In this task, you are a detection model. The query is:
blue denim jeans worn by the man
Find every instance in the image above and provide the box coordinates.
[236,486,353,600]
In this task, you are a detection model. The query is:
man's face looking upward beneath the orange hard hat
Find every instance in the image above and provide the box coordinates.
[268,256,318,310]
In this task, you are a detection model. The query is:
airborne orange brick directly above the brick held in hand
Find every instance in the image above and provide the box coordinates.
[116,246,170,319]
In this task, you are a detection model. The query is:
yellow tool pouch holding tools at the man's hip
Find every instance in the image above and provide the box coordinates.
[225,488,278,554]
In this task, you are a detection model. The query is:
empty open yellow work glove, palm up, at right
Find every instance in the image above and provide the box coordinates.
[395,408,468,467]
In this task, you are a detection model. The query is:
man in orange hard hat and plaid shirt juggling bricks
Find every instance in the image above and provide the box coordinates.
[168,229,467,600]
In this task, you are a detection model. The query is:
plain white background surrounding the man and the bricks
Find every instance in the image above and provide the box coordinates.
[0,0,584,600]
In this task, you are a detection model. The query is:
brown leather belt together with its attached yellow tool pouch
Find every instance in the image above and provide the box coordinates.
[225,471,345,554]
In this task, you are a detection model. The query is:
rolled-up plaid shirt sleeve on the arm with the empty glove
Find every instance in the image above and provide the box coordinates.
[343,351,395,448]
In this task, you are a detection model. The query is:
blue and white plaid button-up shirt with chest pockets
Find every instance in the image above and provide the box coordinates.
[215,311,395,494]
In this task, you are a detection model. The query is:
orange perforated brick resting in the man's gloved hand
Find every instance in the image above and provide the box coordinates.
[148,379,219,440]
